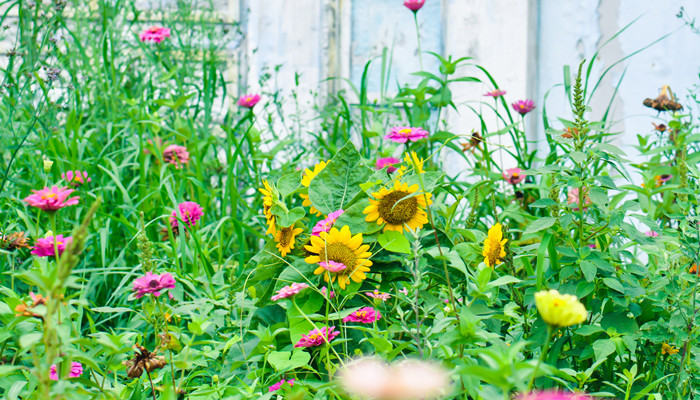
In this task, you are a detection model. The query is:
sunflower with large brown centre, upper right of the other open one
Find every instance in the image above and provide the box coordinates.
[363,181,433,232]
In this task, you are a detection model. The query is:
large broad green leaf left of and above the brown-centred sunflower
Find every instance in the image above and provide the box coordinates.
[309,141,372,215]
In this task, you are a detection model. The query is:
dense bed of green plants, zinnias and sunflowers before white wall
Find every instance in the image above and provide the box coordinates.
[0,0,700,400]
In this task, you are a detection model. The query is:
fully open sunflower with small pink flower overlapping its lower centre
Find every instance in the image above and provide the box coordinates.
[304,225,372,289]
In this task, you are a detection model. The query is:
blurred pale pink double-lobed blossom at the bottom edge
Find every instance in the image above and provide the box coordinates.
[338,358,450,400]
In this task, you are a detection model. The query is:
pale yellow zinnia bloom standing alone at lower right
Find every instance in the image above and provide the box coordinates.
[535,289,588,327]
